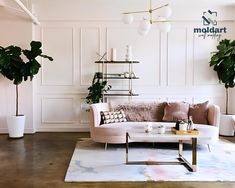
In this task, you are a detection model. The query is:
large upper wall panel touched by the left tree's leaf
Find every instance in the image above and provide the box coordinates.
[42,27,74,86]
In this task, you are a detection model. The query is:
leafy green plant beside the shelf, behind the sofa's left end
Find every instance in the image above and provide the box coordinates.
[86,72,112,104]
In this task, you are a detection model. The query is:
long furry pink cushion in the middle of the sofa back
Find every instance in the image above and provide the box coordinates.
[114,102,165,122]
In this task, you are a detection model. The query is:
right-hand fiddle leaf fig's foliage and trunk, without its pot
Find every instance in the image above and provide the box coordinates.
[210,39,235,115]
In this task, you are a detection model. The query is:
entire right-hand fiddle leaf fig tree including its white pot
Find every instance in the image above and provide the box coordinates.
[210,39,235,136]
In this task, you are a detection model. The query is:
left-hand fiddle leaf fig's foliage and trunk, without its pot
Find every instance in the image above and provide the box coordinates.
[0,41,53,116]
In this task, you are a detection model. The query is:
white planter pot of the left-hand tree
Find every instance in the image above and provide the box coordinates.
[7,115,25,138]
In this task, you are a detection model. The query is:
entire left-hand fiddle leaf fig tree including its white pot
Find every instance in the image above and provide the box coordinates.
[0,41,53,138]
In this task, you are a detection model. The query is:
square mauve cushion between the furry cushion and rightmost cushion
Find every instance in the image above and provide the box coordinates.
[163,102,189,122]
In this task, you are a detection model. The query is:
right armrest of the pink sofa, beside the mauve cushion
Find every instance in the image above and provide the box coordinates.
[207,104,220,127]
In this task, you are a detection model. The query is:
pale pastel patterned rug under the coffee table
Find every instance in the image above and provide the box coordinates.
[65,140,235,182]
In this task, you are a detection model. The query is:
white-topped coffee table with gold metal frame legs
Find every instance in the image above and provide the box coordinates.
[126,130,198,172]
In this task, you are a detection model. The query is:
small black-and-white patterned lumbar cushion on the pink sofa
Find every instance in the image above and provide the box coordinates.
[100,110,127,124]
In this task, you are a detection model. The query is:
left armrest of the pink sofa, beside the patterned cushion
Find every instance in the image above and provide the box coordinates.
[90,103,109,128]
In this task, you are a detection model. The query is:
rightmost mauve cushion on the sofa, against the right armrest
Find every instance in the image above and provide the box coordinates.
[189,101,209,124]
